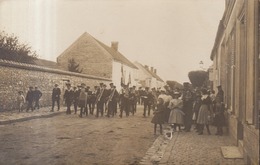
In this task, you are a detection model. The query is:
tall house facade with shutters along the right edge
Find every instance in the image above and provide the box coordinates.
[210,0,260,164]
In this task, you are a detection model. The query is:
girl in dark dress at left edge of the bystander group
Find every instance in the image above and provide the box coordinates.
[151,98,165,135]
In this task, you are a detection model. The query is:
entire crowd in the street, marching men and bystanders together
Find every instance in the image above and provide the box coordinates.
[17,83,225,135]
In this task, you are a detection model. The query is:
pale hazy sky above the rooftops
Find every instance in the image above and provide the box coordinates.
[0,0,225,83]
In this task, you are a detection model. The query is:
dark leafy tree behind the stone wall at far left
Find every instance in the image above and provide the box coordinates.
[0,31,38,64]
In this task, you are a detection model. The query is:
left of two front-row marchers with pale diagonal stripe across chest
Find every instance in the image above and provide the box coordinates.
[96,84,107,117]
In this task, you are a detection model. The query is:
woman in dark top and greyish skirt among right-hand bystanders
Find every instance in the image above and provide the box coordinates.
[197,89,212,135]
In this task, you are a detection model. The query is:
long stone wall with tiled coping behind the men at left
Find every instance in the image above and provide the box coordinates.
[0,60,111,111]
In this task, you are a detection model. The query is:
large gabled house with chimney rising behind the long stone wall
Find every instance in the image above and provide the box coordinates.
[57,32,138,87]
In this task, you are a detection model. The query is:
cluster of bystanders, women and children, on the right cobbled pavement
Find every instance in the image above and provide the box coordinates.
[151,86,225,136]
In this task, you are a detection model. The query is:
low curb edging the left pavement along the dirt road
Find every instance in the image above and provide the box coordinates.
[0,111,64,125]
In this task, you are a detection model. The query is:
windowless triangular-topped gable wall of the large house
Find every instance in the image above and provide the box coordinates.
[57,33,113,79]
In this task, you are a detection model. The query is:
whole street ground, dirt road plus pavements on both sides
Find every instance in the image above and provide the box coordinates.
[0,106,244,165]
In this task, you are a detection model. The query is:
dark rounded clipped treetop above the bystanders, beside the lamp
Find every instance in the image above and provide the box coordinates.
[188,70,208,87]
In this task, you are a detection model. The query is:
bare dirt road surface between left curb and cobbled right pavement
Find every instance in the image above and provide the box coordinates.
[0,106,157,165]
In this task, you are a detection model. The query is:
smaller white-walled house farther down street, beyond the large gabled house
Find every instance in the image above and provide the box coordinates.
[134,61,165,88]
